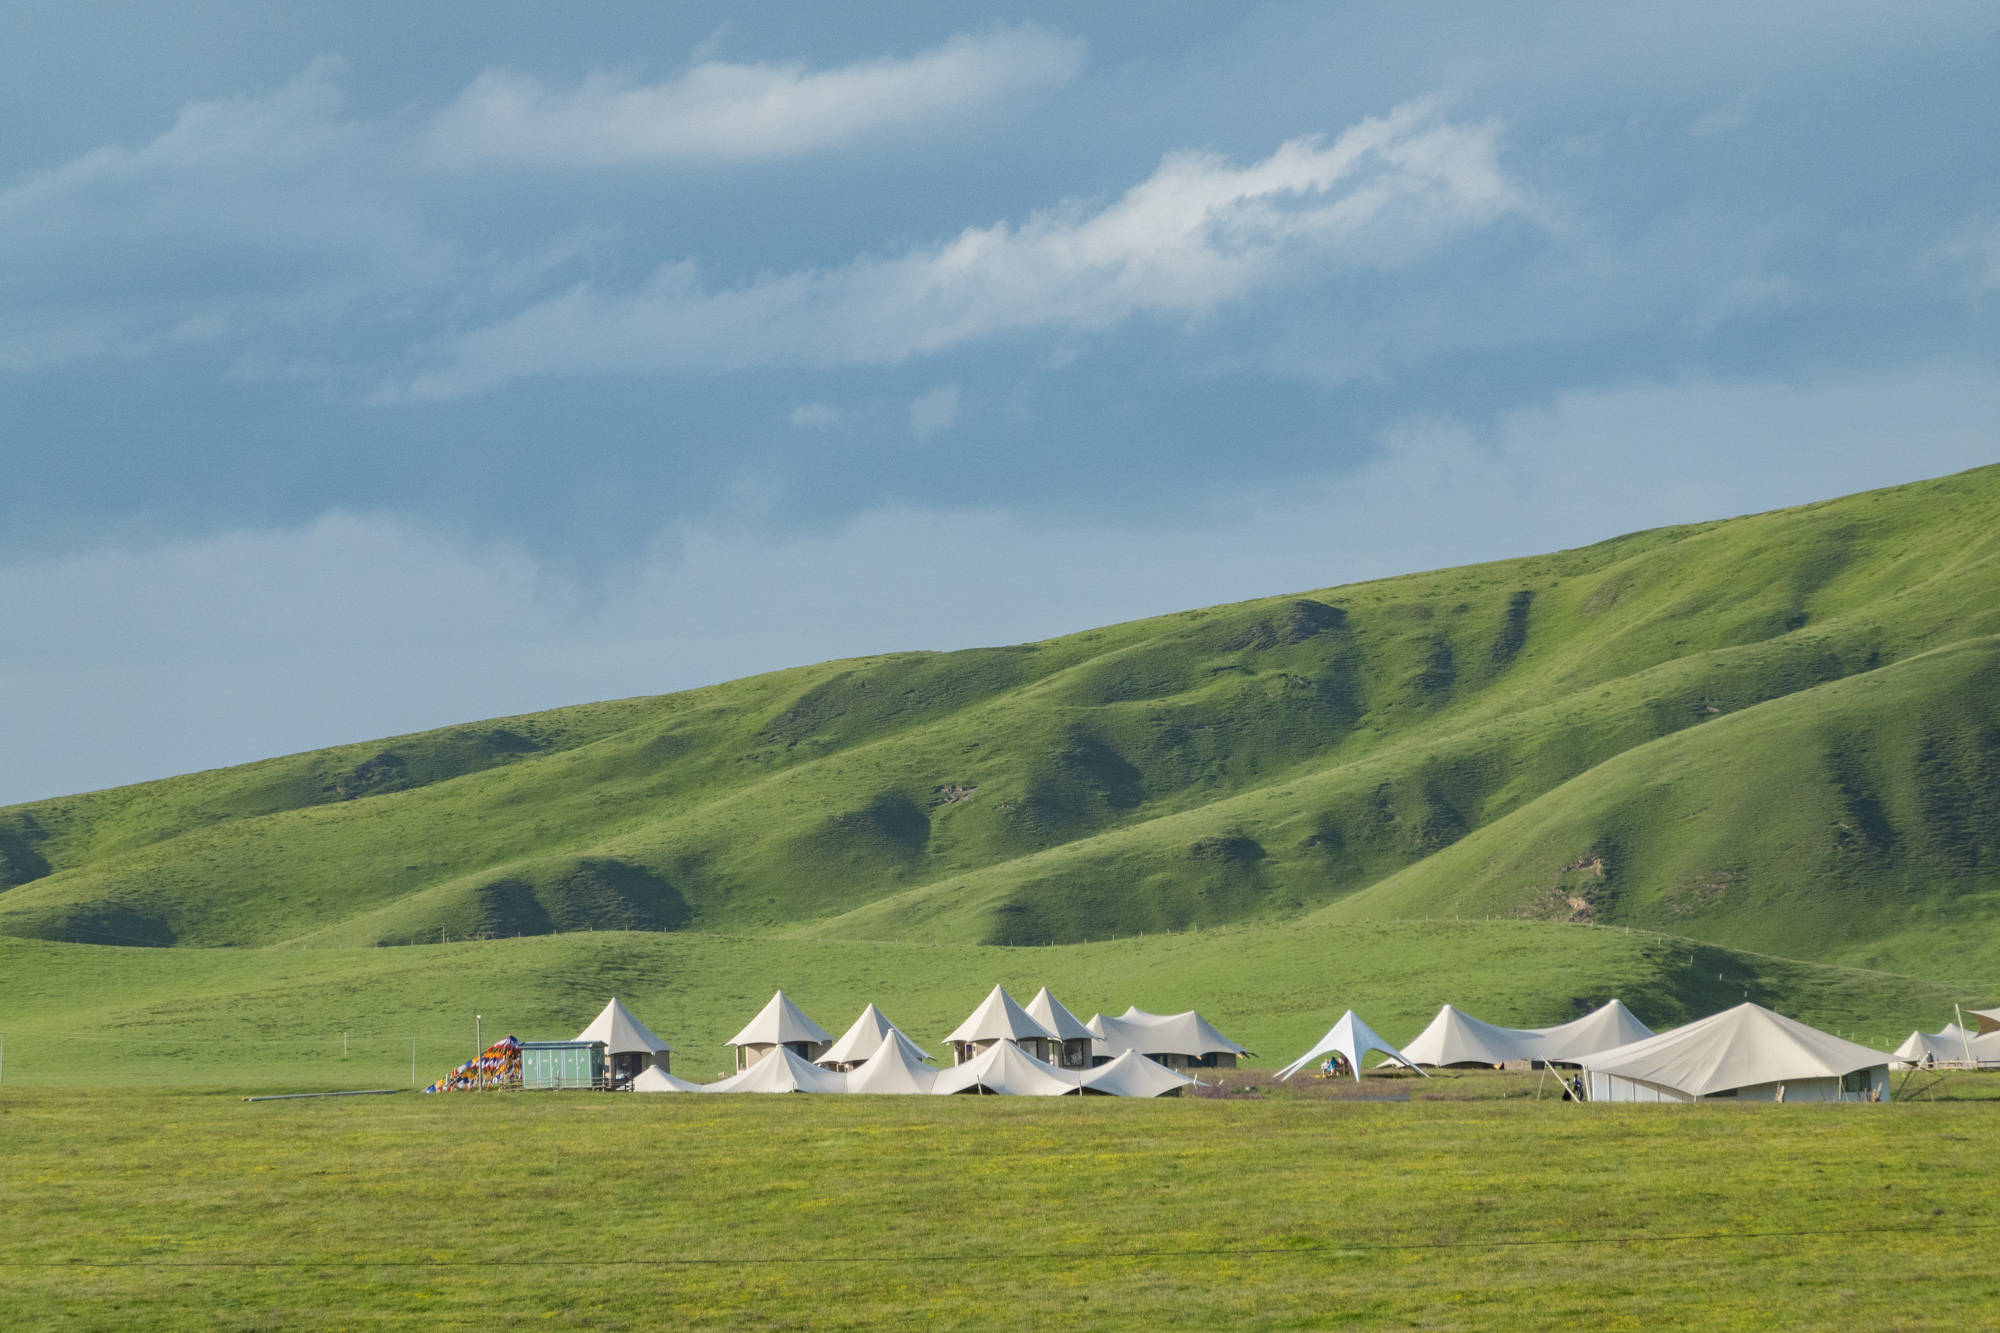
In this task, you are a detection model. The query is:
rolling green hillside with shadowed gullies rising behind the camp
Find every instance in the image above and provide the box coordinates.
[0,468,2000,979]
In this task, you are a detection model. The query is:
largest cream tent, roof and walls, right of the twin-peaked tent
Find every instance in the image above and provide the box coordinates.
[1578,1003,1890,1101]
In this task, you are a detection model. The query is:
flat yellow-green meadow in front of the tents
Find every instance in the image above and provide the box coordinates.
[0,1075,2000,1329]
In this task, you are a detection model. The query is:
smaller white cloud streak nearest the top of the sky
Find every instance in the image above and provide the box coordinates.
[424,28,1084,166]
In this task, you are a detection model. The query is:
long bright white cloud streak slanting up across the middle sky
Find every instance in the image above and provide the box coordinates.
[394,102,1534,398]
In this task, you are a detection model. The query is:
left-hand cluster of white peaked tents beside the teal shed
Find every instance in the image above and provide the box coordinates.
[576,987,1250,1097]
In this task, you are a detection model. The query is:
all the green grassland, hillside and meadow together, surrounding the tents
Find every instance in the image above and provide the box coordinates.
[0,468,2000,1327]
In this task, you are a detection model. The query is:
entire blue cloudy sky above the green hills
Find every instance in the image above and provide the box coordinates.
[0,4,2000,803]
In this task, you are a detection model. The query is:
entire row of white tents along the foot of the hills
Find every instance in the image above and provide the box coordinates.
[578,987,2000,1103]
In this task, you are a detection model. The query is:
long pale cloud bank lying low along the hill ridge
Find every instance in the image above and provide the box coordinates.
[0,360,2000,805]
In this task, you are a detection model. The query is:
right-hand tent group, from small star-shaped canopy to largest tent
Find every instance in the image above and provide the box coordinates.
[1278,999,1912,1103]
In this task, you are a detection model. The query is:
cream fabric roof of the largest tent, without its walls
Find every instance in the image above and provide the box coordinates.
[1578,1003,1890,1097]
